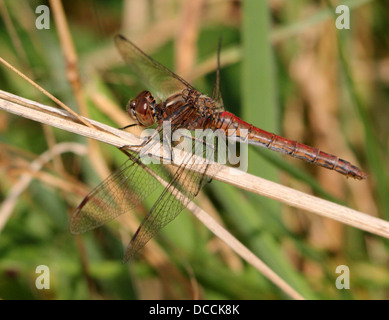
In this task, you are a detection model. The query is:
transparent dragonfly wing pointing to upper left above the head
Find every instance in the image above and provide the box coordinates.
[115,35,194,100]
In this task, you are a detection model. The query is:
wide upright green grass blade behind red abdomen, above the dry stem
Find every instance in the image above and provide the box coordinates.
[242,0,278,180]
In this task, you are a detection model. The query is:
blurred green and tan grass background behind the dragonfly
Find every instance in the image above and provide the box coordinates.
[0,0,389,299]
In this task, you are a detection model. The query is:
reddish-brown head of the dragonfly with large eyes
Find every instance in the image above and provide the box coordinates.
[127,91,156,127]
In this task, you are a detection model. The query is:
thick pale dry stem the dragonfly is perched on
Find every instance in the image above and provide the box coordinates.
[0,90,389,238]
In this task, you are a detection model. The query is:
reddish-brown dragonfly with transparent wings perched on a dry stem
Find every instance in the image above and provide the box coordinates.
[70,35,367,262]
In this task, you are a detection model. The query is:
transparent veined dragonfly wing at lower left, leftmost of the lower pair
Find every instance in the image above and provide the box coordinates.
[70,152,168,234]
